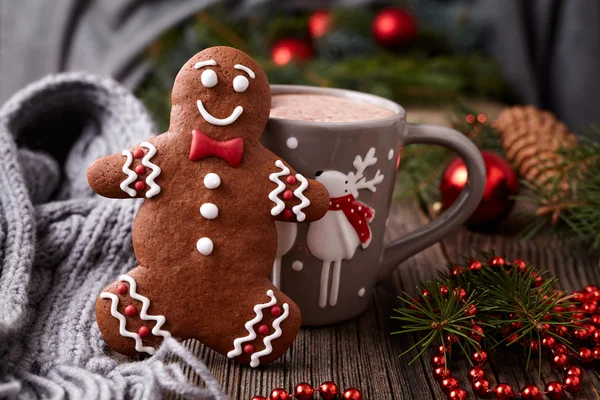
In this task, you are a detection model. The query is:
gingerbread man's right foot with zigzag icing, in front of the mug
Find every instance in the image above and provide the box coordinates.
[223,285,302,367]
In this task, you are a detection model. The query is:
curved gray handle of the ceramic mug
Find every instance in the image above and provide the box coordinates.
[378,124,486,283]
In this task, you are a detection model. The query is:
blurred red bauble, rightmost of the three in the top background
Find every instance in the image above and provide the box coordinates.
[372,8,417,49]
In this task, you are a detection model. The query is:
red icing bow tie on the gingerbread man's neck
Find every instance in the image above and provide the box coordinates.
[190,129,244,168]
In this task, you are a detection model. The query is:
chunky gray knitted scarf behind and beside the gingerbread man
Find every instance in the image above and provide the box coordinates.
[0,73,226,399]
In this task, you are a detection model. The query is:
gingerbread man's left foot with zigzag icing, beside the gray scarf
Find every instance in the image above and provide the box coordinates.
[96,267,171,356]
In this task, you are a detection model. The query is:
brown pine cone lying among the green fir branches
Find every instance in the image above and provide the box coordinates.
[492,106,577,197]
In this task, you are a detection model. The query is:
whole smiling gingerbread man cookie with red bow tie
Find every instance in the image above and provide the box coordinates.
[88,47,329,367]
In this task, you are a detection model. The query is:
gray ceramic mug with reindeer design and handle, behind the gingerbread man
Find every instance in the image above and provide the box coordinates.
[262,85,485,326]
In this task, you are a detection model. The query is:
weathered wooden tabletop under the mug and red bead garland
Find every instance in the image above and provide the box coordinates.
[175,203,600,400]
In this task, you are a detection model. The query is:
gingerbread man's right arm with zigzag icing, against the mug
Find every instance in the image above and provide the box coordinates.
[267,158,329,222]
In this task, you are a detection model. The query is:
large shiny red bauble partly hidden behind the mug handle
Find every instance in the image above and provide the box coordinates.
[440,151,519,227]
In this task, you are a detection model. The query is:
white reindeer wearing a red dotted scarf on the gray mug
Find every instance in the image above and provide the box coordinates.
[307,147,383,308]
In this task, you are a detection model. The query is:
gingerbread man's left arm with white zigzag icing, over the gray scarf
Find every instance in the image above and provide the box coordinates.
[87,138,162,198]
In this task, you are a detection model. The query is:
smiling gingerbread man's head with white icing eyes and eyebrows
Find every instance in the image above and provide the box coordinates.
[169,46,271,140]
